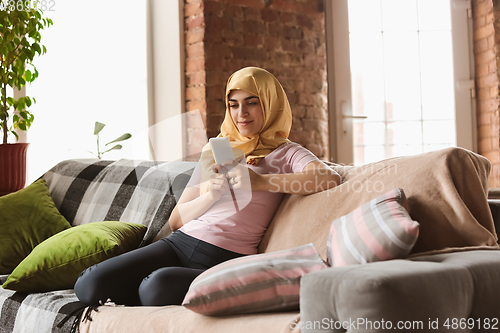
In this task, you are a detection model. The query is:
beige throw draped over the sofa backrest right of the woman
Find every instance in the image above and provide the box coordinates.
[259,148,498,258]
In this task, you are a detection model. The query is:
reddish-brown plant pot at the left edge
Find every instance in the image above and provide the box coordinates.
[0,143,28,196]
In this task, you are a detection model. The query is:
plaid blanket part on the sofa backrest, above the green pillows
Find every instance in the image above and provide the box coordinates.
[43,160,196,243]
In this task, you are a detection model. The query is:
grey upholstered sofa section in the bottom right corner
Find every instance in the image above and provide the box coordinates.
[298,200,500,333]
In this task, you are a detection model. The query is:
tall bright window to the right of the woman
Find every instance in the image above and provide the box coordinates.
[327,0,474,165]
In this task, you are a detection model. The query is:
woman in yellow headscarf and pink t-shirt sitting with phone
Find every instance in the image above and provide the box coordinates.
[75,67,340,306]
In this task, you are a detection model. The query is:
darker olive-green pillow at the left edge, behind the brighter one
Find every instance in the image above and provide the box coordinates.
[0,179,71,274]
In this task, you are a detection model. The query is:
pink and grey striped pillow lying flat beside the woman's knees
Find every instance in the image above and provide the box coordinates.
[182,244,328,315]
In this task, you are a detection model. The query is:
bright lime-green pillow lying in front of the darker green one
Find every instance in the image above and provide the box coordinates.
[2,221,147,292]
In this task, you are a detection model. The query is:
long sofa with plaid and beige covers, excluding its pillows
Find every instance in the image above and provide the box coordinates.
[0,148,500,333]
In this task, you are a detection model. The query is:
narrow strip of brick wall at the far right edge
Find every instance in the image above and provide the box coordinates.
[472,0,500,187]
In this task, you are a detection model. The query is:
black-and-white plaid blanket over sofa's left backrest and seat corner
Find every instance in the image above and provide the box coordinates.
[0,159,196,333]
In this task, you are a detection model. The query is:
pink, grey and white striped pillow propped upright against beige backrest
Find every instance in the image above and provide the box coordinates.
[327,188,419,267]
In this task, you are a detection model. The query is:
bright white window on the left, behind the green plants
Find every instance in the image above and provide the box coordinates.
[26,0,149,182]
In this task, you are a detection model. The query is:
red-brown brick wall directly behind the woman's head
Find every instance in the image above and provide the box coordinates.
[185,0,329,159]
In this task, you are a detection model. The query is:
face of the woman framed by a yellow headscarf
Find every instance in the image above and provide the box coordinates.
[228,90,264,137]
